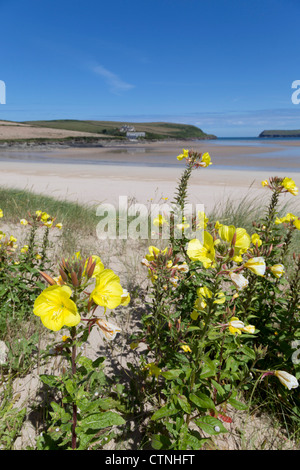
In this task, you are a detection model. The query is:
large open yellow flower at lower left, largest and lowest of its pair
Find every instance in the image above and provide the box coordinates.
[33,285,80,331]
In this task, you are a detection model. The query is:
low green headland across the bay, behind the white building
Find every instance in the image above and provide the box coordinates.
[23,119,216,139]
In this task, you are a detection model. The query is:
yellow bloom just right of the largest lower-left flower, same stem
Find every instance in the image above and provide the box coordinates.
[91,269,123,309]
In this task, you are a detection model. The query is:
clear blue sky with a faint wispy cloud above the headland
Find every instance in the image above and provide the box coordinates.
[0,0,300,136]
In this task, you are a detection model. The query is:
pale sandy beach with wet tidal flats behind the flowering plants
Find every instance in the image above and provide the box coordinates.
[0,141,300,211]
